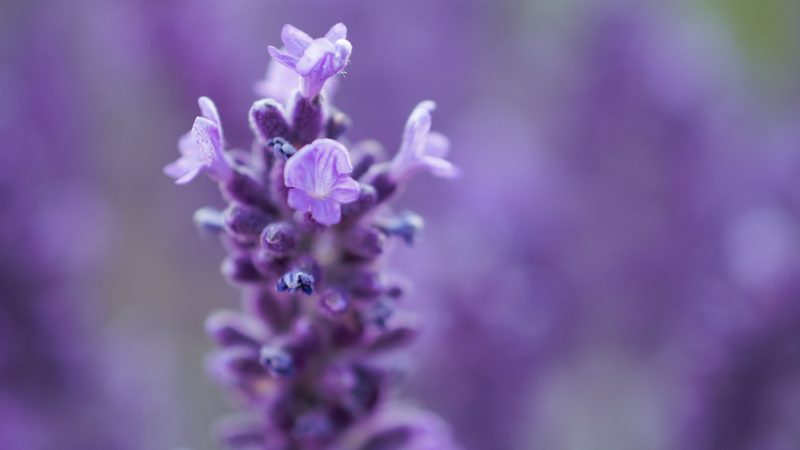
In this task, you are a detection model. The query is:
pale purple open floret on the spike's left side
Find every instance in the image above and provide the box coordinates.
[164,97,233,184]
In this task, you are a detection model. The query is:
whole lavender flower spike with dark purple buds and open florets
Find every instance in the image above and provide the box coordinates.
[165,24,459,450]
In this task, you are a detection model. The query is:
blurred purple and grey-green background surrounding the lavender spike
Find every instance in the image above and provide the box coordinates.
[0,0,800,450]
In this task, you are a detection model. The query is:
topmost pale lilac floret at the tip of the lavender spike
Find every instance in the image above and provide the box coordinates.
[268,23,353,98]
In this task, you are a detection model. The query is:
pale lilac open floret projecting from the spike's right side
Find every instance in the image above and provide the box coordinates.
[388,100,461,183]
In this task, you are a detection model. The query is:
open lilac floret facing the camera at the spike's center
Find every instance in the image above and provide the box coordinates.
[283,139,359,225]
